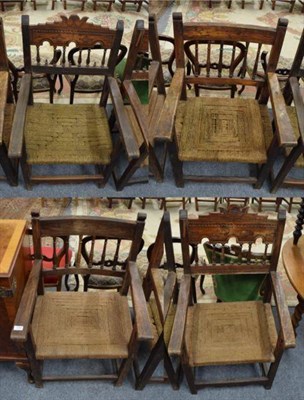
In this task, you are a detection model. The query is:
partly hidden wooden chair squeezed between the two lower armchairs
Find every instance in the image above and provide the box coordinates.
[135,211,179,390]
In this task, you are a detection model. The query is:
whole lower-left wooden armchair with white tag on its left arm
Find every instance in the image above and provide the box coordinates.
[11,214,153,387]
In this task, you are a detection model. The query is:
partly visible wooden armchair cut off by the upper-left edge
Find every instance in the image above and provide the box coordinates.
[0,18,18,186]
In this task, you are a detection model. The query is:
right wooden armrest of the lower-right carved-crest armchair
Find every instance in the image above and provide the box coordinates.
[271,271,296,348]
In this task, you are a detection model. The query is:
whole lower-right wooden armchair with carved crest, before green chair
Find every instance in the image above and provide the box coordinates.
[169,210,295,394]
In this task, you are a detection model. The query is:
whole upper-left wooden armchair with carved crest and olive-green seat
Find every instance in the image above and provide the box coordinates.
[9,15,139,188]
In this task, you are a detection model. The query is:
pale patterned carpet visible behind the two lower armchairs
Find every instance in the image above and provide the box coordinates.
[0,198,297,306]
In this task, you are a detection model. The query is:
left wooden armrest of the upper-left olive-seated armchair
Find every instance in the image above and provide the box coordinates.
[8,74,32,158]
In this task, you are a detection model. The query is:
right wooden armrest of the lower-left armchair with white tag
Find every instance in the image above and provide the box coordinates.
[129,261,153,340]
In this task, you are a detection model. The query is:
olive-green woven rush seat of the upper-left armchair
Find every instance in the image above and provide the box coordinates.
[25,104,113,165]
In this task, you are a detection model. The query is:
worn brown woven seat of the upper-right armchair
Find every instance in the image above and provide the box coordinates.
[176,97,272,164]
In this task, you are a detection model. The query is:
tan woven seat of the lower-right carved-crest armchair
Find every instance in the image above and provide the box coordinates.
[185,301,277,366]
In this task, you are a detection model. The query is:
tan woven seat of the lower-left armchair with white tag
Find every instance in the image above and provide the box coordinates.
[33,292,132,359]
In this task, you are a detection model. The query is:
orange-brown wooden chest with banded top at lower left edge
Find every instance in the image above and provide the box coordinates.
[0,220,31,361]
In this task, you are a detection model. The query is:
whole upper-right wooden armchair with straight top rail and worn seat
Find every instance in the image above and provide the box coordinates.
[155,13,294,188]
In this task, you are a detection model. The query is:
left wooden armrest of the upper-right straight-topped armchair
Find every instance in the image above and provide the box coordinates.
[154,68,185,141]
